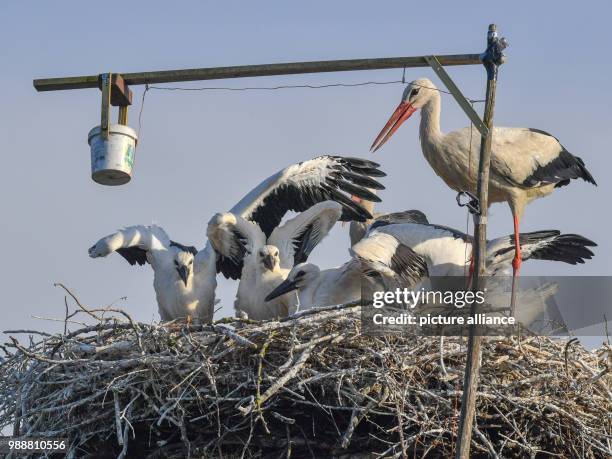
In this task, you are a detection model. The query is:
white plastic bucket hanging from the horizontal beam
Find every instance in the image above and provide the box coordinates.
[87,124,138,186]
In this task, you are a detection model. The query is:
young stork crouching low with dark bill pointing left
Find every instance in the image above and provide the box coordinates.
[266,233,427,310]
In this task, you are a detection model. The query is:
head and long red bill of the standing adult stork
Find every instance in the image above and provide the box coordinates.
[370,78,437,152]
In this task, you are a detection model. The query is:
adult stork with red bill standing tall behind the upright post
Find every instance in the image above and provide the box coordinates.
[371,78,596,284]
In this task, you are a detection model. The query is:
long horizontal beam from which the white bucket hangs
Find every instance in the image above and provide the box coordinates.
[34,54,481,91]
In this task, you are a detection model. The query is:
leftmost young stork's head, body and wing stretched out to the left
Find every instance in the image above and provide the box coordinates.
[89,225,217,323]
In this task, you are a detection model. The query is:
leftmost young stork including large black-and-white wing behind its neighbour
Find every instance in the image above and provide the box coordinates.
[89,155,385,322]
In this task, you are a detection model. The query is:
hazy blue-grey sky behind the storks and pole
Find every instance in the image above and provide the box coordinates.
[0,1,612,344]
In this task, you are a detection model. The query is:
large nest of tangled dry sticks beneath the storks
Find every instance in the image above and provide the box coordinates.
[0,296,612,458]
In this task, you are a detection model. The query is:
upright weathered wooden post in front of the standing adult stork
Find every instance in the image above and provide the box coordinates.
[455,24,506,459]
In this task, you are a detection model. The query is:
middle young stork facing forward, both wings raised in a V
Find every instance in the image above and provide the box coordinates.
[207,201,342,320]
